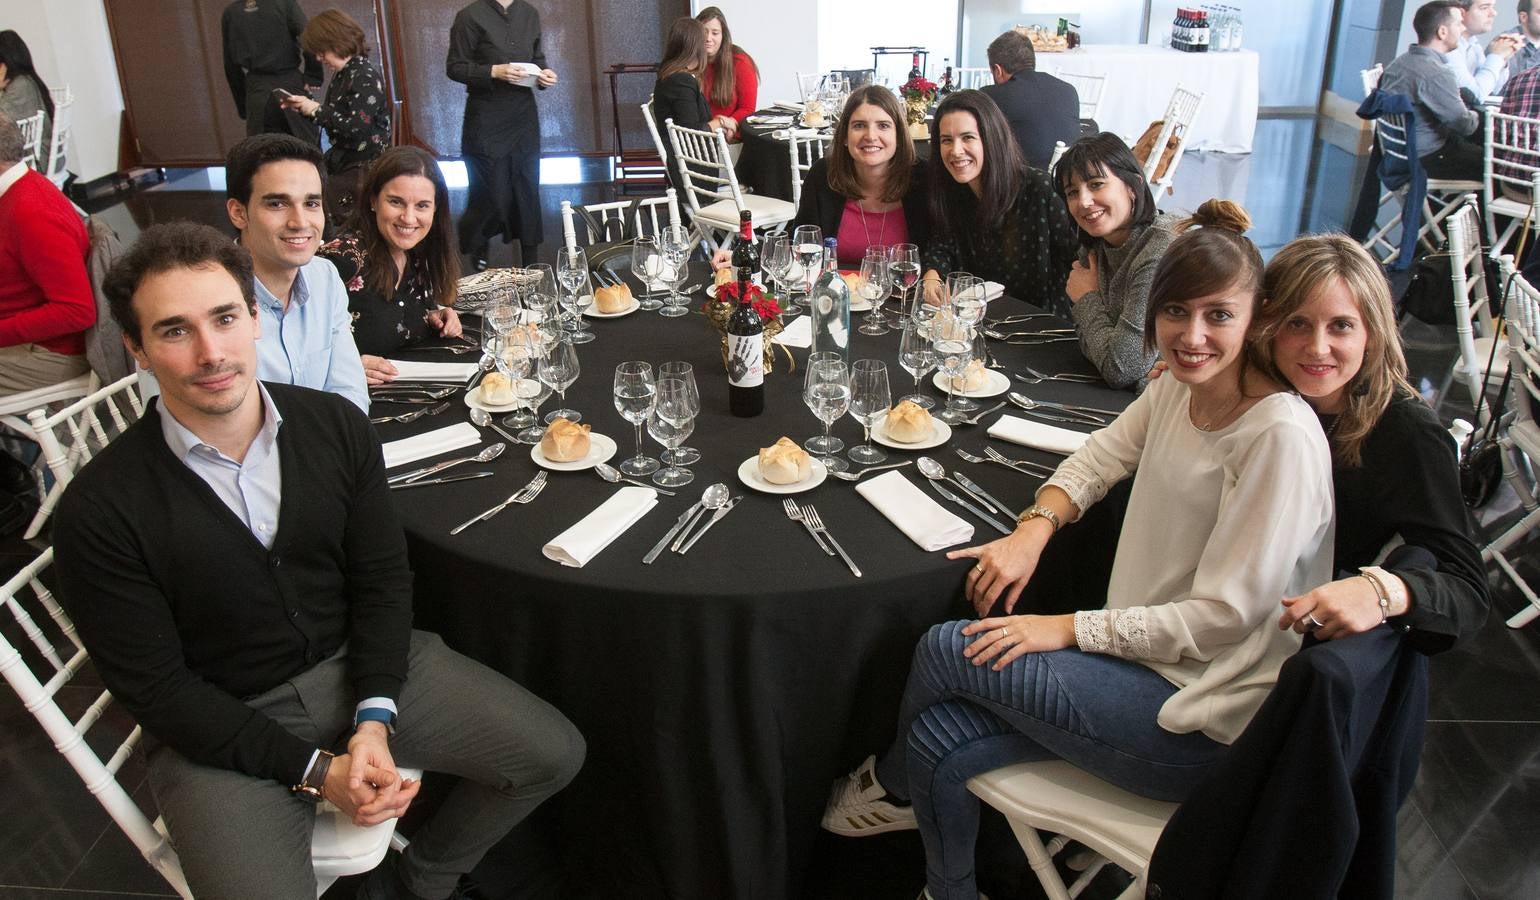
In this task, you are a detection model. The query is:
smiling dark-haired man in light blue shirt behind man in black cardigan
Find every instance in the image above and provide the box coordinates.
[140,134,369,411]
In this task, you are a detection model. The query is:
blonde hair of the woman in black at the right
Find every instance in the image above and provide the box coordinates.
[1257,234,1415,465]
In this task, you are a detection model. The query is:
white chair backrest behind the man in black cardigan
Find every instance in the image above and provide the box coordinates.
[0,549,193,897]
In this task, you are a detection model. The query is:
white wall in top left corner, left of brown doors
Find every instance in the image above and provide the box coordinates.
[0,0,125,182]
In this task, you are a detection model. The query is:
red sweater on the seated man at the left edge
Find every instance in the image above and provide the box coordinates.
[0,170,95,356]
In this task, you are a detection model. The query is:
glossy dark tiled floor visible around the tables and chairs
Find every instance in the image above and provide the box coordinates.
[0,119,1540,900]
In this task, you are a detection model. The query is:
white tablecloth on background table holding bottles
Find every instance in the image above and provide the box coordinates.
[1038,43,1258,153]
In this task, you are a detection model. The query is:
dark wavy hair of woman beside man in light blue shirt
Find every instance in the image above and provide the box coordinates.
[348,146,460,307]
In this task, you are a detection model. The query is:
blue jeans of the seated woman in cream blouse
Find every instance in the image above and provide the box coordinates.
[876,621,1227,900]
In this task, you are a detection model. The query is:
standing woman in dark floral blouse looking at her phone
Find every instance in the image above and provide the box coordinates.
[283,9,390,227]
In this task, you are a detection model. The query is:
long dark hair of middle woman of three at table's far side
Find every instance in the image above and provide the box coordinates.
[927,91,1027,234]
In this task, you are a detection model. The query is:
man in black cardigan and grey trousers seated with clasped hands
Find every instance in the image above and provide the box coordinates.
[55,223,584,900]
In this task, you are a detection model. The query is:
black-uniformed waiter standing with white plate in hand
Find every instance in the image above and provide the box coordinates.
[445,0,556,271]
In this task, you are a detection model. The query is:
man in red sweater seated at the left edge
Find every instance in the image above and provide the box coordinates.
[0,113,95,396]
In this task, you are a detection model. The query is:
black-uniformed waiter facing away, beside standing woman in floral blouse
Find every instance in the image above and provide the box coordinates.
[219,0,322,146]
